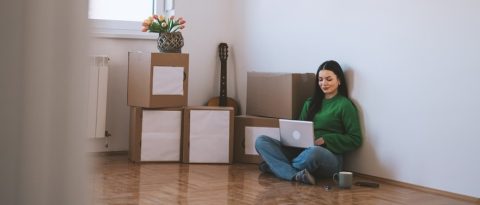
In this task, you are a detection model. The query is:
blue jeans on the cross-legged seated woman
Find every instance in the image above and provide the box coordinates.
[255,135,343,180]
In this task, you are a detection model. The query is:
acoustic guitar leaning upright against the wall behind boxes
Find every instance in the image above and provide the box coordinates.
[207,43,239,115]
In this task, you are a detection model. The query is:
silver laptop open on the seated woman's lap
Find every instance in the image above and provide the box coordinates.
[278,119,315,148]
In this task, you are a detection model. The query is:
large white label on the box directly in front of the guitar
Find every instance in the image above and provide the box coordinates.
[189,110,230,163]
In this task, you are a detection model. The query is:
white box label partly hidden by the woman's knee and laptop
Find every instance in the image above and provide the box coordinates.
[245,126,280,155]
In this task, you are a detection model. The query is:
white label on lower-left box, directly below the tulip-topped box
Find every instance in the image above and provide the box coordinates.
[140,110,182,161]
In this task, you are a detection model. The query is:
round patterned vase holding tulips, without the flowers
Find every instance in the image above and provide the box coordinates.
[157,32,183,53]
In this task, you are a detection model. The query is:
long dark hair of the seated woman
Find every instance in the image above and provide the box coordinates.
[306,60,349,121]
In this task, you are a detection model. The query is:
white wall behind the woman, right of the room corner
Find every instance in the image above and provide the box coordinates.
[234,0,480,197]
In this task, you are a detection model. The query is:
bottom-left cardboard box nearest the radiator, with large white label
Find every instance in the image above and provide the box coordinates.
[129,107,183,162]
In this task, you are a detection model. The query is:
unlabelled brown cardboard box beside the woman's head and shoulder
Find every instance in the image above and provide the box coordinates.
[246,72,316,119]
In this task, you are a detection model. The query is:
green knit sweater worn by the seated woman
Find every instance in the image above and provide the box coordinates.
[299,95,362,154]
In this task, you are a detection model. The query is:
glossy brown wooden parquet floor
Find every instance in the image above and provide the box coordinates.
[91,155,478,205]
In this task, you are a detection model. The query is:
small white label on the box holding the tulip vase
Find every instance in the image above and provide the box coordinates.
[152,66,184,95]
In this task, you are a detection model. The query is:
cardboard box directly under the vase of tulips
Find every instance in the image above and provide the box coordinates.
[127,52,188,108]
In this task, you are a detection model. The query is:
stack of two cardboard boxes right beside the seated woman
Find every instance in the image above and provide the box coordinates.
[234,72,316,163]
